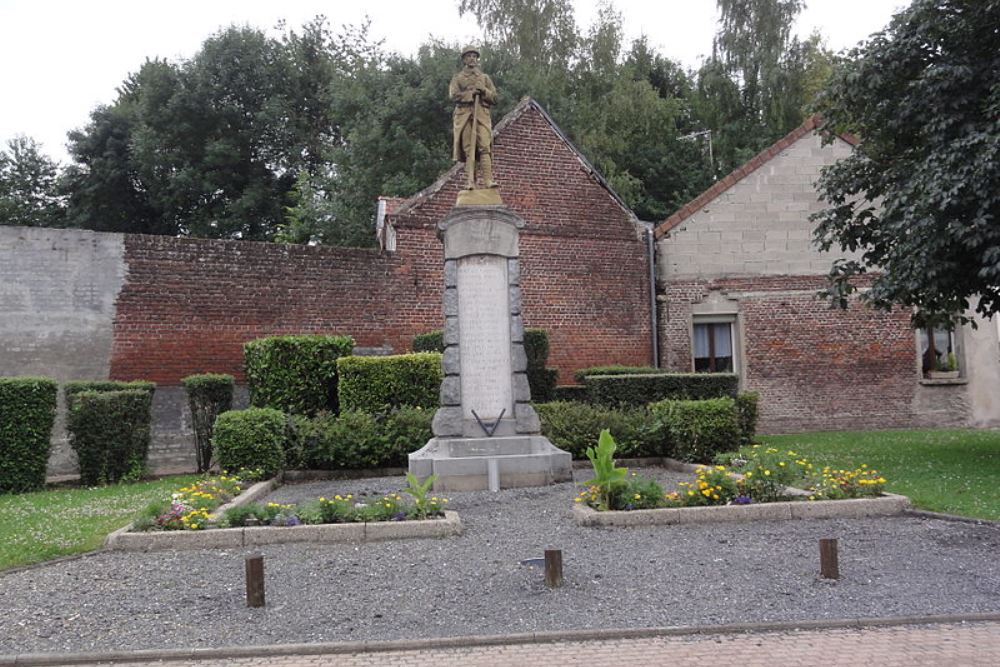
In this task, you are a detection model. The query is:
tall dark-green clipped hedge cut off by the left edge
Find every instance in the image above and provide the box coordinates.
[0,377,59,493]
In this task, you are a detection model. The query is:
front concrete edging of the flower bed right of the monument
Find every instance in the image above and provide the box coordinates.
[573,493,910,527]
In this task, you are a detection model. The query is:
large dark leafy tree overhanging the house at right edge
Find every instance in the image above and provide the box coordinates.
[815,0,1000,326]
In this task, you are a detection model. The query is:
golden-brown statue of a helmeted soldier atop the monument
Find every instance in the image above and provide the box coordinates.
[448,46,497,190]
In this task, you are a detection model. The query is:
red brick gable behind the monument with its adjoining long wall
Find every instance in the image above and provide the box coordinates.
[111,105,652,384]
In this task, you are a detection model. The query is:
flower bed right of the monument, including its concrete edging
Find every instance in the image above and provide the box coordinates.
[574,432,909,525]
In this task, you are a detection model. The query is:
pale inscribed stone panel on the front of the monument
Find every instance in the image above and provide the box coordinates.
[458,255,514,420]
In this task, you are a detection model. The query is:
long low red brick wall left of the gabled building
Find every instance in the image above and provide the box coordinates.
[111,235,399,384]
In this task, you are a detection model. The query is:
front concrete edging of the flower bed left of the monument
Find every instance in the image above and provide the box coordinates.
[106,510,462,551]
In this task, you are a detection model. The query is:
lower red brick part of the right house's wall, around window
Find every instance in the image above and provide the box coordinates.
[660,276,930,433]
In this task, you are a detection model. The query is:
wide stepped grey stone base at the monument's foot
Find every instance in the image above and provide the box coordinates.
[410,435,573,491]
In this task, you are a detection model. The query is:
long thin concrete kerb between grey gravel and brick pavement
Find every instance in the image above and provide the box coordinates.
[0,612,1000,667]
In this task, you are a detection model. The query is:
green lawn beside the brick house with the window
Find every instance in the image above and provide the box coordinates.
[759,429,1000,520]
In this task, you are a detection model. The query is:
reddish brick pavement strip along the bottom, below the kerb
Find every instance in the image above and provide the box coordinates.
[11,620,1000,667]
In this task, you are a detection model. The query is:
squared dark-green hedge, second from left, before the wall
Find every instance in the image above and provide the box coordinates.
[66,383,153,486]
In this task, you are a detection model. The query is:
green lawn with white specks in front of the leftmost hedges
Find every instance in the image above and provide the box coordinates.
[0,475,197,570]
